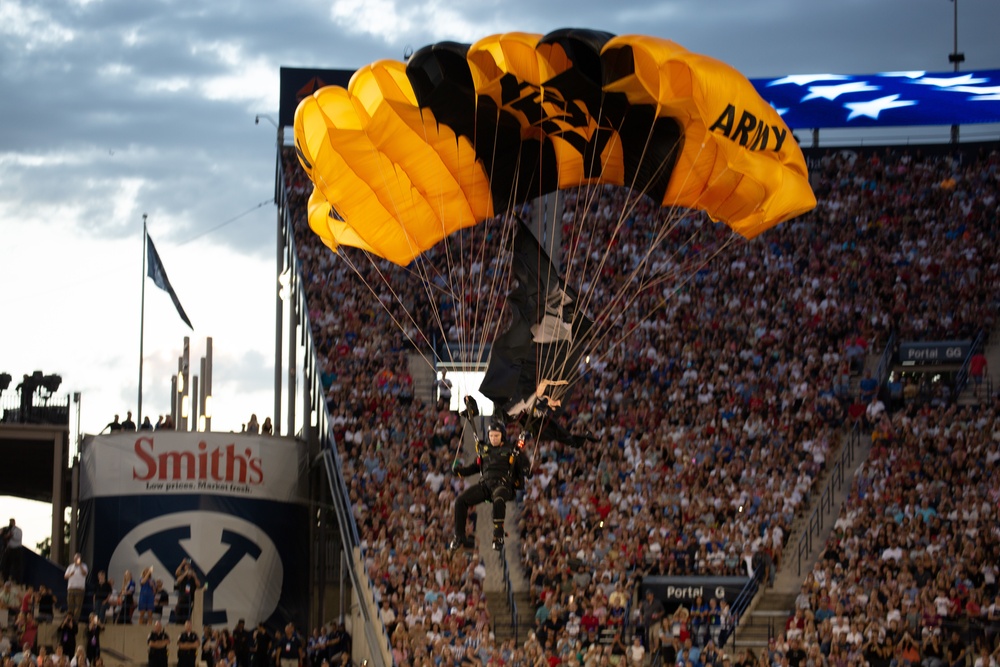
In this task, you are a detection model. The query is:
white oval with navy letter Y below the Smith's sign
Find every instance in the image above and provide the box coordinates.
[108,512,284,625]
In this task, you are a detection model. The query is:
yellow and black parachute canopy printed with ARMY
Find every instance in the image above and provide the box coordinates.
[295,29,816,266]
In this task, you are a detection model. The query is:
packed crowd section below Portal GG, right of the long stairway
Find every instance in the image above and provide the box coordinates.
[760,403,1000,667]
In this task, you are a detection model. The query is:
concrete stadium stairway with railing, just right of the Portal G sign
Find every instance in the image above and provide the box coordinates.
[726,431,871,655]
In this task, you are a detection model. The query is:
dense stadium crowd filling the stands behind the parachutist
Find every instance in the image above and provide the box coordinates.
[276,144,1000,667]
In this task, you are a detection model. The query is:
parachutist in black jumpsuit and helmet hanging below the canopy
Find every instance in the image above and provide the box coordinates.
[452,423,531,549]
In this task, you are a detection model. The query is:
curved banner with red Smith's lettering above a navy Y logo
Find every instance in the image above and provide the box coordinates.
[80,431,309,627]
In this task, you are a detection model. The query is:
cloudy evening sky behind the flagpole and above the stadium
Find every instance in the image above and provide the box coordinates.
[0,0,1000,544]
